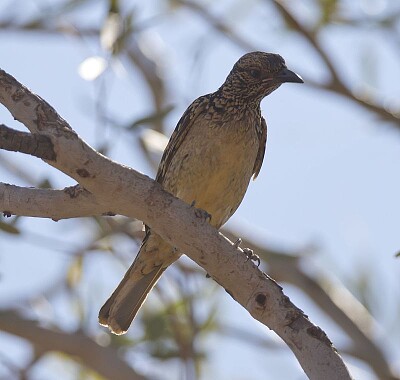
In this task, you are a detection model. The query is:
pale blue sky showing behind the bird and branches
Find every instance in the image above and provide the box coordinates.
[0,1,400,379]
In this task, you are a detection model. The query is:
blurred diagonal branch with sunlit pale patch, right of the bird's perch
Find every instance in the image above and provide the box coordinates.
[223,229,399,380]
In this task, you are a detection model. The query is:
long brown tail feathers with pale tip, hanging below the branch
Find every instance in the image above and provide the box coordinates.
[99,262,166,335]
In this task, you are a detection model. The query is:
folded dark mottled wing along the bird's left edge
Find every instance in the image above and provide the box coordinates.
[156,95,210,185]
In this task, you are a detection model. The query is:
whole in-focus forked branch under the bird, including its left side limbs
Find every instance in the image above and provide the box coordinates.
[0,70,351,380]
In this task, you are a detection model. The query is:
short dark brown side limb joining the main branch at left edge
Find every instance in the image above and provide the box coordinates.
[0,124,56,161]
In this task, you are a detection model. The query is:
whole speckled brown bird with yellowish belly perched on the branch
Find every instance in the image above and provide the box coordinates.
[99,51,303,335]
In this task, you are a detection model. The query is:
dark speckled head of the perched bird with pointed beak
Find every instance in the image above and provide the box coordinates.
[221,51,303,104]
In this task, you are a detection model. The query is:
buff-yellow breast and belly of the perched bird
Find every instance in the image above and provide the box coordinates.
[164,119,259,227]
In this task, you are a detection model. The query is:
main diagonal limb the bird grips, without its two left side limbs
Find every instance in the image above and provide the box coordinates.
[0,67,351,380]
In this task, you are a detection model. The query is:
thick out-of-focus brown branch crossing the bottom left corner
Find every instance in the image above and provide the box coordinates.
[0,312,146,380]
